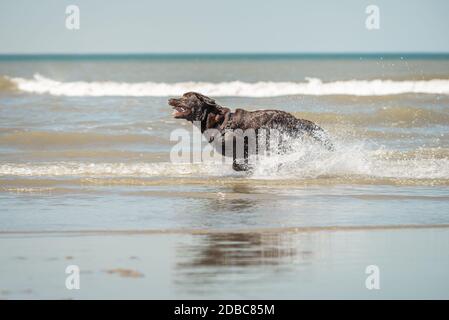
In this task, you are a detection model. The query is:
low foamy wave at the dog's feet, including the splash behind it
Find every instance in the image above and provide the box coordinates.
[0,143,449,181]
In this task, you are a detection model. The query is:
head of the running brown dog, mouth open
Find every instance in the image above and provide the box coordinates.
[168,92,218,121]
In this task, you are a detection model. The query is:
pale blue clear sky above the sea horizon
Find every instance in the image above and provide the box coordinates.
[0,0,449,53]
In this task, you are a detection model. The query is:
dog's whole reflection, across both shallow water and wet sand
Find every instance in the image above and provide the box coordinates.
[174,183,315,293]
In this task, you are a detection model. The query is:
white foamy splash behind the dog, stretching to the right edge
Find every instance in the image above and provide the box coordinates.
[253,141,449,180]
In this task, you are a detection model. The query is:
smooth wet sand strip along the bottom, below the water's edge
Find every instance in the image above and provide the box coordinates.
[0,226,449,299]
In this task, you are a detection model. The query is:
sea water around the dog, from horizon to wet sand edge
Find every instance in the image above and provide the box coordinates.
[0,57,449,230]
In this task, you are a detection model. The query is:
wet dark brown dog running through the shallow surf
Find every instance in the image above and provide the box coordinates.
[168,92,334,171]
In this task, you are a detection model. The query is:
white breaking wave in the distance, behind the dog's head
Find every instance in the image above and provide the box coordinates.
[2,74,449,98]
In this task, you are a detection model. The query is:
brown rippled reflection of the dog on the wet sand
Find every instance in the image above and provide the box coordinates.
[175,233,314,292]
